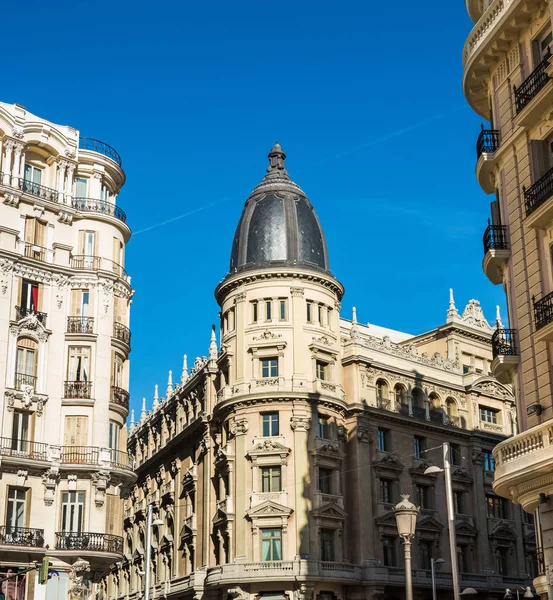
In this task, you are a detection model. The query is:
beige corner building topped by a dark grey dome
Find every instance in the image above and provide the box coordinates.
[109,144,536,600]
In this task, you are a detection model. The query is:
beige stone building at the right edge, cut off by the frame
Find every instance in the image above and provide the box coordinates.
[463,0,553,598]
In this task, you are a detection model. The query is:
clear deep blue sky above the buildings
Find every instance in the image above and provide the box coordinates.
[0,0,504,418]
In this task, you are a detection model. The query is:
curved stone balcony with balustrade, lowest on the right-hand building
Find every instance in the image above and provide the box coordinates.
[493,421,553,512]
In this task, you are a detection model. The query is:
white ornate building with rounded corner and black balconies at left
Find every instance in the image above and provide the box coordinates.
[0,103,136,600]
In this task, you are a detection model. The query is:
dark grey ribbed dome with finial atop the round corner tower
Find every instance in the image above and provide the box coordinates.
[230,142,329,273]
